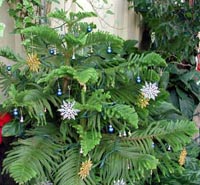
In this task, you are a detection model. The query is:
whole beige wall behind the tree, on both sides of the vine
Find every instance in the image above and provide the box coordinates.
[0,0,140,55]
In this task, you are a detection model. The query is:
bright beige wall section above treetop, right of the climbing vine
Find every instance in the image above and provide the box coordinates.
[52,0,140,40]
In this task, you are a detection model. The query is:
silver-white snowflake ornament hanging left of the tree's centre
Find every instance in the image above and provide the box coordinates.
[58,100,80,120]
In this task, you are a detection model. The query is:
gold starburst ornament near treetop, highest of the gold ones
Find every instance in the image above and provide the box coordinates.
[27,53,41,72]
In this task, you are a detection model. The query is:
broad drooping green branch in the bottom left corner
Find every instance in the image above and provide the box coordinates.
[3,136,58,184]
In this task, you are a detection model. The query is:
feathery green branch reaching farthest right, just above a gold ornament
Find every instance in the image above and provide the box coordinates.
[123,120,197,152]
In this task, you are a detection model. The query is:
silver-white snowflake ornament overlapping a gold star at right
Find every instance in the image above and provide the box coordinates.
[141,82,160,100]
